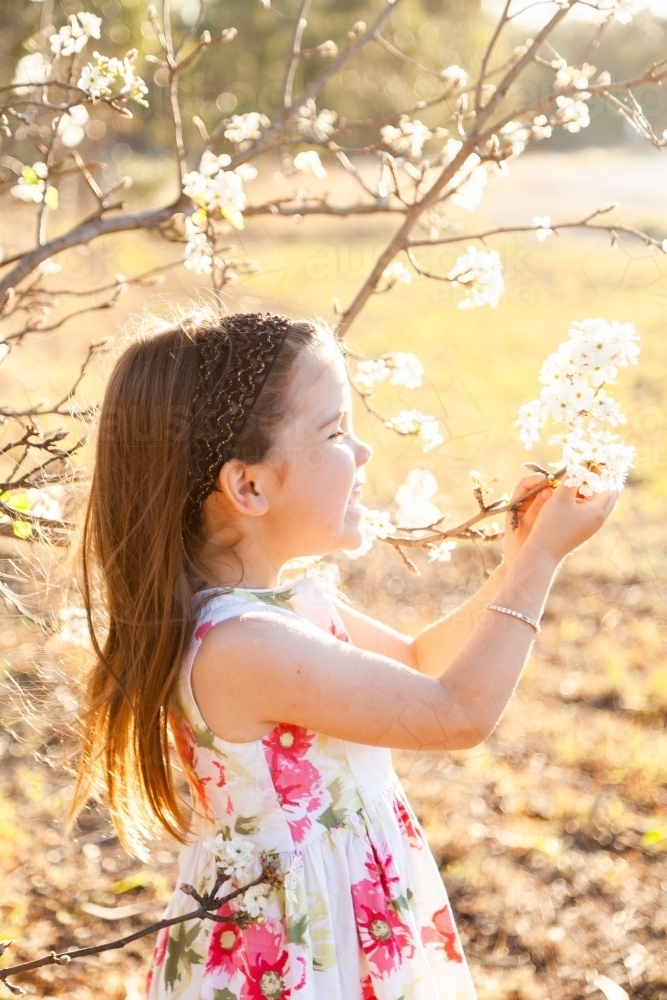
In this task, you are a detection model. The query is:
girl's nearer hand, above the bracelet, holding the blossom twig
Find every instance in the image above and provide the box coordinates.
[524,483,618,562]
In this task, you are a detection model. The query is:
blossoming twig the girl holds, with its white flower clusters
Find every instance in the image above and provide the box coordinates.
[350,319,639,573]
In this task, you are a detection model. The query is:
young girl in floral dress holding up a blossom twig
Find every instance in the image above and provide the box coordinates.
[77,311,616,1000]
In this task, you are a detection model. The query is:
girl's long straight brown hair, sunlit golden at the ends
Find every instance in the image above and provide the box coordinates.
[70,309,326,854]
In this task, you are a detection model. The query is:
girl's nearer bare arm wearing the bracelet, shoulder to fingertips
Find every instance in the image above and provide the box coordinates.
[193,486,616,750]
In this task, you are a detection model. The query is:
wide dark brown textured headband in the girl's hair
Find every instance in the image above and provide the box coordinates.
[185,313,292,527]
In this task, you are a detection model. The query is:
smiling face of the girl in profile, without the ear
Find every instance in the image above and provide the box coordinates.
[267,346,371,561]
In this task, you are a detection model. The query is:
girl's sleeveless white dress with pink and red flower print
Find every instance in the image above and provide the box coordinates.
[147,577,475,1000]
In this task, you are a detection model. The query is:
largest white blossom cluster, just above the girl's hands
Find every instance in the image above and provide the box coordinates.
[517,319,639,496]
